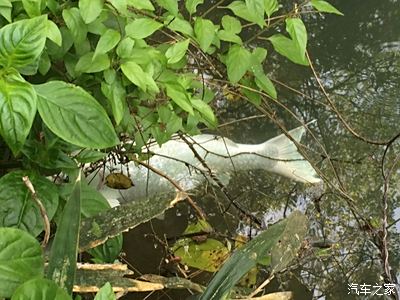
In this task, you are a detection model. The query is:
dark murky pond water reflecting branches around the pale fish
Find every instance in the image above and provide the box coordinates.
[124,0,400,299]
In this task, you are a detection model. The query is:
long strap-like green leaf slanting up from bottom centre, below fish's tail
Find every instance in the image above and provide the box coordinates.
[200,211,306,300]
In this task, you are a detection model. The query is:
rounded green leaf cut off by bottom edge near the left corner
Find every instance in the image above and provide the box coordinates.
[11,278,72,300]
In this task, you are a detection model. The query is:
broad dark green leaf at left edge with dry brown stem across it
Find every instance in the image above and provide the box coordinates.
[0,171,58,236]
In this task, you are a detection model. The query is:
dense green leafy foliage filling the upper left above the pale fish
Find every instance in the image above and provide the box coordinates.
[0,0,354,299]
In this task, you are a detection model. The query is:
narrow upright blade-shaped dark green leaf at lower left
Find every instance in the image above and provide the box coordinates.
[47,173,81,295]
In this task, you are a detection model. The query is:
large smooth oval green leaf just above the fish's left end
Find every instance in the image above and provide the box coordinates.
[34,81,119,149]
